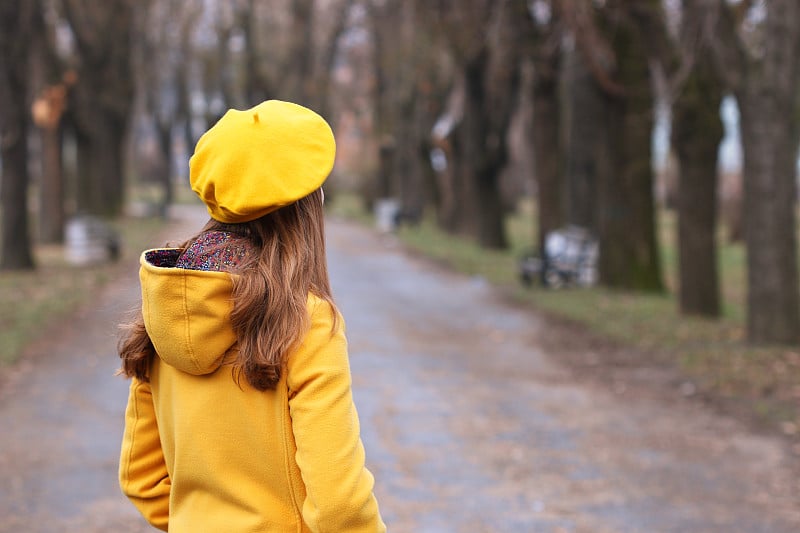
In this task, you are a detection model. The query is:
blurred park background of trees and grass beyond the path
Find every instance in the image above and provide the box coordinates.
[0,0,800,435]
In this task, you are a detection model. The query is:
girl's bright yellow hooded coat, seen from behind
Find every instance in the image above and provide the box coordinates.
[119,251,386,533]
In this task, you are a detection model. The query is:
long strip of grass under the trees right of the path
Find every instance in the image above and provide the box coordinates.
[334,193,800,437]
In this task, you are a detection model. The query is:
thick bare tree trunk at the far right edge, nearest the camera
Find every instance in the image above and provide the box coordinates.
[708,0,800,343]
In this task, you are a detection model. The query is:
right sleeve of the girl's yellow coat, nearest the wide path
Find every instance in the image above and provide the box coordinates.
[287,303,386,533]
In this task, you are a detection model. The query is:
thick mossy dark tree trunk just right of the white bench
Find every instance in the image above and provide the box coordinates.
[561,0,663,291]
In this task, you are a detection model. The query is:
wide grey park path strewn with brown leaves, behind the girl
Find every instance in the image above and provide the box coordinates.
[0,205,800,533]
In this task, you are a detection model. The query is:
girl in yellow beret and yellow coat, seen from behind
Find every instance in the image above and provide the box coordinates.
[119,100,386,533]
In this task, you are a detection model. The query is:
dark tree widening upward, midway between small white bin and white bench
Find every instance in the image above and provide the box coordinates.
[432,0,528,248]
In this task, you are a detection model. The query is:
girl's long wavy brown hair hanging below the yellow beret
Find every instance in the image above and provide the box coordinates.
[119,189,337,390]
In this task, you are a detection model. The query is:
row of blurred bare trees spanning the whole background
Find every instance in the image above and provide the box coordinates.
[0,0,800,343]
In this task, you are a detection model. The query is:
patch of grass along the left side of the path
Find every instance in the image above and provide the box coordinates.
[0,212,164,368]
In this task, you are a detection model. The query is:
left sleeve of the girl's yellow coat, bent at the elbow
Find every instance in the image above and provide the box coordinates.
[119,378,170,531]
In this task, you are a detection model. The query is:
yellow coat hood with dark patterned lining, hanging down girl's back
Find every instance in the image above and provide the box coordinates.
[139,248,236,376]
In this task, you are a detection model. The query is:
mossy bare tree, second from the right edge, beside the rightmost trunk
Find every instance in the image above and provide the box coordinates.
[631,0,724,316]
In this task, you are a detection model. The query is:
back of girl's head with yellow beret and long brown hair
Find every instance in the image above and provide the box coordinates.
[190,100,336,390]
